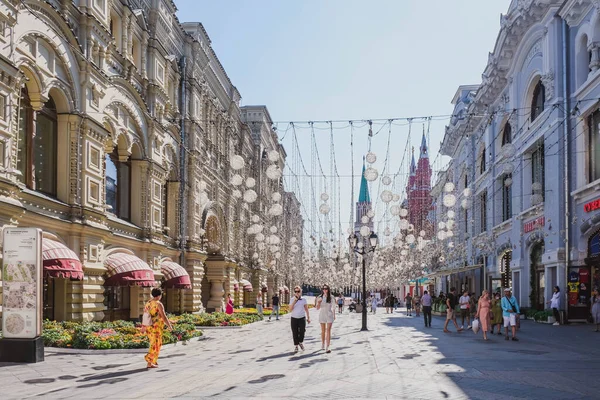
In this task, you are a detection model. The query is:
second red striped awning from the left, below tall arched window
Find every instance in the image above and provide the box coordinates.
[104,253,156,286]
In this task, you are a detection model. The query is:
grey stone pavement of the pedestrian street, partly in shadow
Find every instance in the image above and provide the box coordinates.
[0,310,600,399]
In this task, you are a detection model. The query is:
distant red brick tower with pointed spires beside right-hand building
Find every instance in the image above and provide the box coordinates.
[406,132,433,239]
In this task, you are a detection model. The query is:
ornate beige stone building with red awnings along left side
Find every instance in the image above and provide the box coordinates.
[0,0,302,320]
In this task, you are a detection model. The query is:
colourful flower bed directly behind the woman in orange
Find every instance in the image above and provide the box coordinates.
[42,320,202,349]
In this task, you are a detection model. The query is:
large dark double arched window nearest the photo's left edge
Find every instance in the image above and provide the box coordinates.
[17,88,58,197]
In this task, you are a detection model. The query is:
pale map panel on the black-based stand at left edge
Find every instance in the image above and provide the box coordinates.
[2,228,42,339]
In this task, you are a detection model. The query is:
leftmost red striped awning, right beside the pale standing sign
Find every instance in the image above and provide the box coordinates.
[42,238,83,281]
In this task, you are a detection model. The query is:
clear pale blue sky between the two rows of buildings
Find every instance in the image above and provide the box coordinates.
[176,0,510,247]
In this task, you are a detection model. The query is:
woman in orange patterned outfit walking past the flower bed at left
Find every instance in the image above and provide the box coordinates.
[142,288,173,368]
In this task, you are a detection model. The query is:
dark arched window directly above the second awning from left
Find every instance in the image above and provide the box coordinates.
[106,147,131,221]
